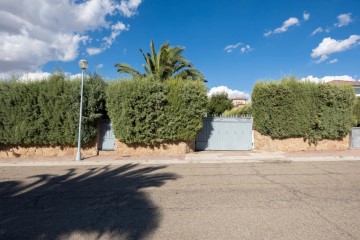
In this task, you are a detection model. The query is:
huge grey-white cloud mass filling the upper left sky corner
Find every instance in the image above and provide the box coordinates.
[0,0,141,75]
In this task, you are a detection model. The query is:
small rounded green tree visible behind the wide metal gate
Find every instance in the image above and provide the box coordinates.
[207,93,233,115]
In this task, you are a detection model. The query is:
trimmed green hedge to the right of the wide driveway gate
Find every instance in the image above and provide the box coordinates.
[252,78,355,142]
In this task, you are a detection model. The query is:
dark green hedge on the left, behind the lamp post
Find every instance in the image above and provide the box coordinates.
[0,72,106,145]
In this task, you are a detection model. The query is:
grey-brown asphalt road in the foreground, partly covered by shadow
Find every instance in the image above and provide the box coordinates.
[0,161,360,240]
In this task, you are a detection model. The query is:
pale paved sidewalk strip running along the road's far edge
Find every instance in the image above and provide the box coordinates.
[0,149,360,166]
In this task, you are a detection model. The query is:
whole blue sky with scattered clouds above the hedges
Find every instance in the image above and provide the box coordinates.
[0,0,360,96]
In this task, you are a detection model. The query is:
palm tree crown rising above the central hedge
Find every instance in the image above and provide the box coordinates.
[115,41,206,81]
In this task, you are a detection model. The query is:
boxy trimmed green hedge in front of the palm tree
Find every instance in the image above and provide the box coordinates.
[106,79,207,144]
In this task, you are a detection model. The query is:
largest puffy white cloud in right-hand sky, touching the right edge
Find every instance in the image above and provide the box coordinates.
[311,35,360,63]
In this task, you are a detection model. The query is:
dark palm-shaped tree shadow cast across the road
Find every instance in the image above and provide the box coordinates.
[0,164,177,239]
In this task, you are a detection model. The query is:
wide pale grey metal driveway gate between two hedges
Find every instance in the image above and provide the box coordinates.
[195,117,253,151]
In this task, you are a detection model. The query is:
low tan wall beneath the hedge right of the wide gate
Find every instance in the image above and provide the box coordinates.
[254,130,350,152]
